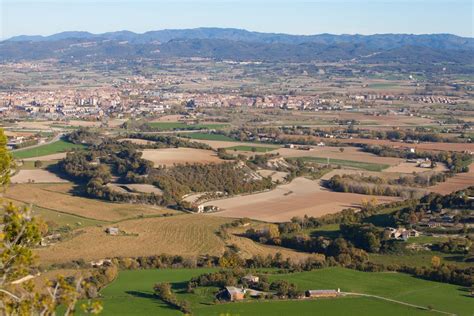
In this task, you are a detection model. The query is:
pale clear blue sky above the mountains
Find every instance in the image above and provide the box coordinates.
[0,0,474,39]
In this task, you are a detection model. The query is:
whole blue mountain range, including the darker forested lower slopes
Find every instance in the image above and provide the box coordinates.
[0,28,474,64]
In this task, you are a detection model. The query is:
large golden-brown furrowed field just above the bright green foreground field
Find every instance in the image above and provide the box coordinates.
[36,215,307,263]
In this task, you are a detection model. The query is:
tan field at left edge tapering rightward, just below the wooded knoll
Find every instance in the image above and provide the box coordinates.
[5,183,173,221]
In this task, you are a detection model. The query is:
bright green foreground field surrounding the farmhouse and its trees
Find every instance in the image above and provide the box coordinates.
[90,268,472,315]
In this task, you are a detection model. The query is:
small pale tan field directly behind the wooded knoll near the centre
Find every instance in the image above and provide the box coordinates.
[143,148,223,166]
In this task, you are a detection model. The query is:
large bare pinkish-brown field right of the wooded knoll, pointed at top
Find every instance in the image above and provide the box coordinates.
[204,178,398,222]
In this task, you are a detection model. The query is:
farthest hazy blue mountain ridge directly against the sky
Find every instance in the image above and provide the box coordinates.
[7,27,474,49]
